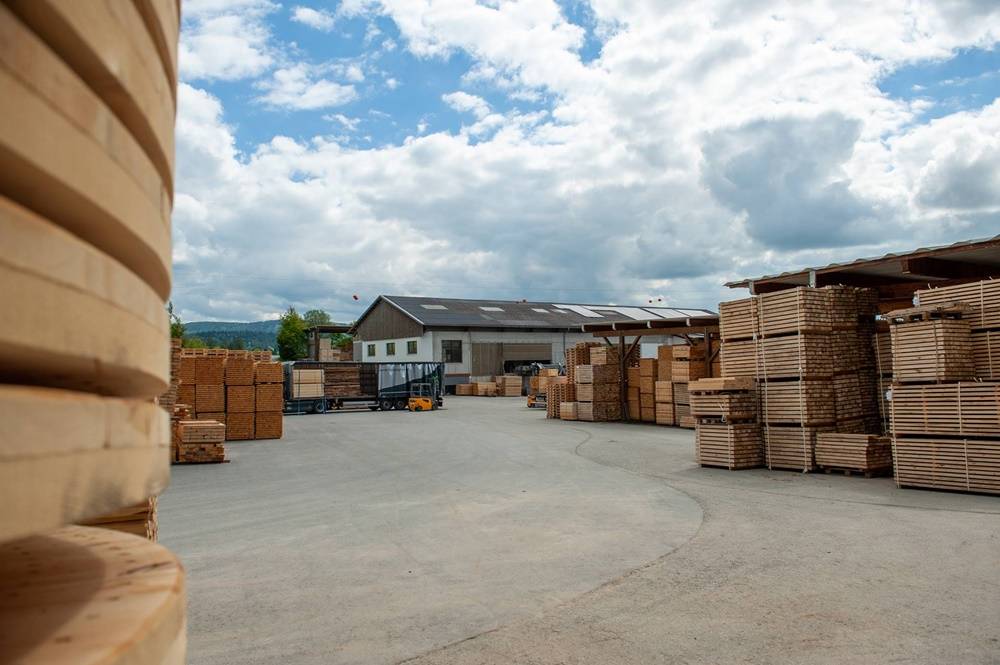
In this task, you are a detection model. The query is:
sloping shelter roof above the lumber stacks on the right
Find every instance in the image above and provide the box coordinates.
[726,235,1000,289]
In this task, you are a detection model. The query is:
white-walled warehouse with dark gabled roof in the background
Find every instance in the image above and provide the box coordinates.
[351,296,714,385]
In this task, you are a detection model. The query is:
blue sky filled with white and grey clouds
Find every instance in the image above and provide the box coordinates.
[174,0,1000,320]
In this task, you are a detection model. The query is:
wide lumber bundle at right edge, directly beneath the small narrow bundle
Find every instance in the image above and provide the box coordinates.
[891,381,1000,437]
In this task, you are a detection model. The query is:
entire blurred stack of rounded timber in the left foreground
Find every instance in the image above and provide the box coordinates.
[0,0,186,665]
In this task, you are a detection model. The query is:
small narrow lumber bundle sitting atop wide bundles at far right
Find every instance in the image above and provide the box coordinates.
[886,303,975,383]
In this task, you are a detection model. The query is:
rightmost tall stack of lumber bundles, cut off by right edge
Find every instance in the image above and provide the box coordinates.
[889,281,1000,494]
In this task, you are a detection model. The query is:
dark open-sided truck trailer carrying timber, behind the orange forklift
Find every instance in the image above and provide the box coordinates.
[284,360,444,413]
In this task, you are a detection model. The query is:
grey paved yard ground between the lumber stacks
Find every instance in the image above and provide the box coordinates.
[160,398,1000,665]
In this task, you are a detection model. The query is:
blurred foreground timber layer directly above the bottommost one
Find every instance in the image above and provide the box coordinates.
[0,385,170,541]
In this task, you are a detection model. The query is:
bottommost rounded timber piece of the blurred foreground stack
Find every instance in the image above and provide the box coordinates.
[0,526,185,665]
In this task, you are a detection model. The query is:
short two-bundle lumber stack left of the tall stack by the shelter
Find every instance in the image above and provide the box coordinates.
[687,377,764,470]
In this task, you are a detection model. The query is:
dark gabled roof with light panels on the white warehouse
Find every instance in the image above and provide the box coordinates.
[354,296,715,330]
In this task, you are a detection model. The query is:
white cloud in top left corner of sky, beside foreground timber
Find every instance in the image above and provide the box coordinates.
[178,0,278,81]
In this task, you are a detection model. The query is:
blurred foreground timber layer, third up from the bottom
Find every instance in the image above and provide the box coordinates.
[0,197,170,398]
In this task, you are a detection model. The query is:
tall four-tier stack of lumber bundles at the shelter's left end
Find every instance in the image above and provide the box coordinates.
[719,286,878,471]
